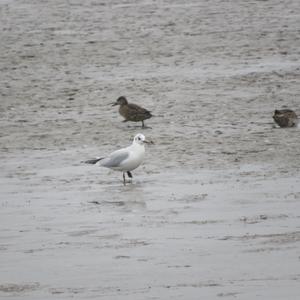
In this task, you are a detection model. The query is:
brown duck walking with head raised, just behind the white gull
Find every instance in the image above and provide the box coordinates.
[113,96,152,128]
